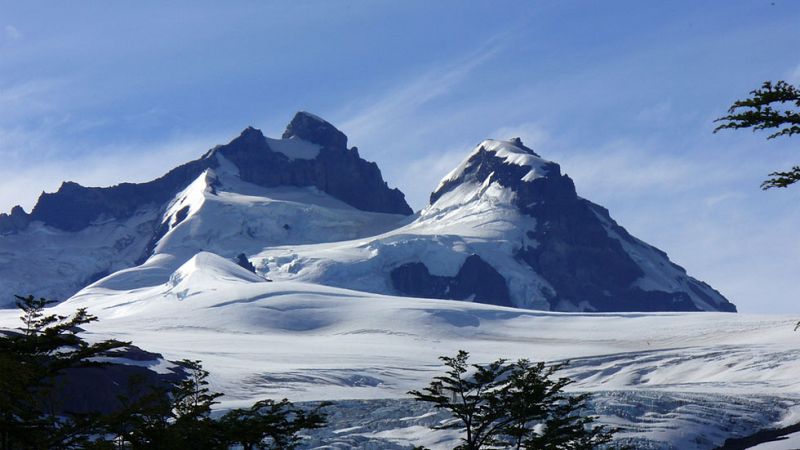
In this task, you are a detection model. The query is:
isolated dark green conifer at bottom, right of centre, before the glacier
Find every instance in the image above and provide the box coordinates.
[409,350,614,450]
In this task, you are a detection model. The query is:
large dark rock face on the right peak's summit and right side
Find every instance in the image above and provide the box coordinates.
[431,142,736,311]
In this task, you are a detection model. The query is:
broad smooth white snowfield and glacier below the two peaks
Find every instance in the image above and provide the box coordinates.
[0,252,800,449]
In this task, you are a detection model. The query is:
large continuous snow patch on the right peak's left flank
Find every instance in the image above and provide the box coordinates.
[251,176,549,309]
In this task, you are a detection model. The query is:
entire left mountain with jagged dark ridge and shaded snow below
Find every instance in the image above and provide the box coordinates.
[0,112,411,306]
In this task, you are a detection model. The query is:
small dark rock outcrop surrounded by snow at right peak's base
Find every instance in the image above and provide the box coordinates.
[391,255,513,306]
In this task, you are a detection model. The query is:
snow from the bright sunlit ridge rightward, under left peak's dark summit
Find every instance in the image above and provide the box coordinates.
[79,155,407,296]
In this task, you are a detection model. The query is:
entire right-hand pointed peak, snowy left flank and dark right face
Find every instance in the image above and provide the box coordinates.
[256,139,736,311]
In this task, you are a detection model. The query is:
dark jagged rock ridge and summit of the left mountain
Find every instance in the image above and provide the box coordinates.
[0,112,412,234]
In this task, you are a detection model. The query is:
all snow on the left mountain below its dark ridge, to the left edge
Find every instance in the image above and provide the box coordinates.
[0,155,407,305]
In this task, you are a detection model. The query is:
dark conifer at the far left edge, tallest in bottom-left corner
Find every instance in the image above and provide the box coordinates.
[0,296,128,450]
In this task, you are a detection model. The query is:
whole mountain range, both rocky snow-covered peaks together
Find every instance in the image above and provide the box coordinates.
[0,112,736,312]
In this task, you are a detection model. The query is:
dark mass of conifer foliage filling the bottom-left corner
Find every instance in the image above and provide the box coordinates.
[0,297,328,450]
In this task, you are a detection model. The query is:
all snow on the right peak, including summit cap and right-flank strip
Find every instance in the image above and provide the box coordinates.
[251,146,717,311]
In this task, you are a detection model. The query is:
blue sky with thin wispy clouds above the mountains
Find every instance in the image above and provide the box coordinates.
[0,0,800,313]
